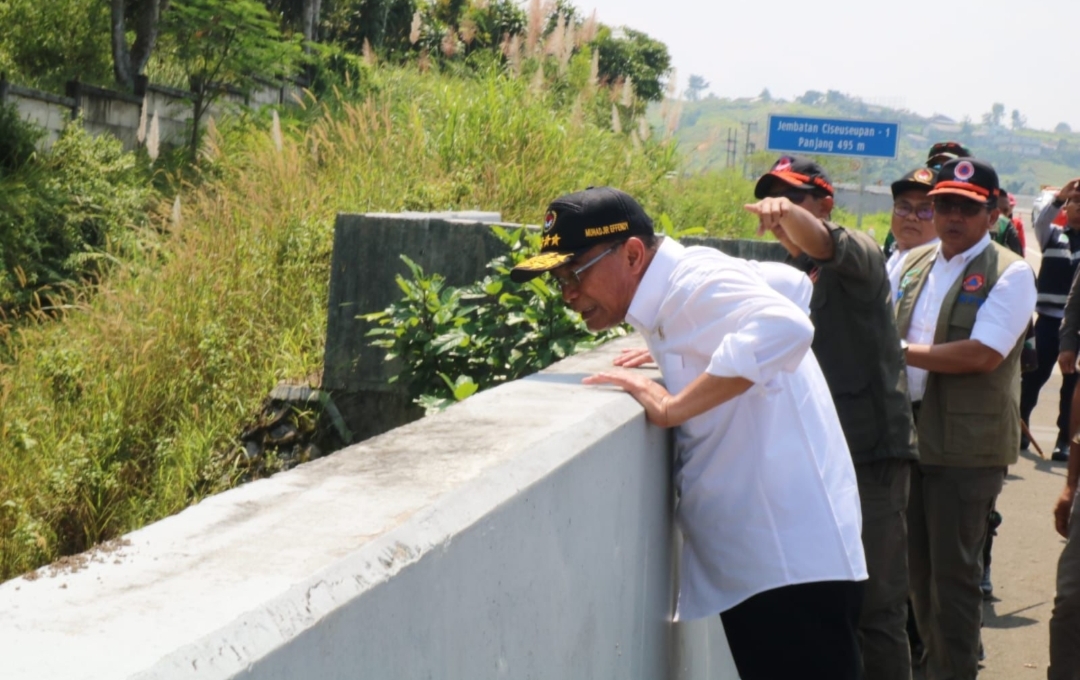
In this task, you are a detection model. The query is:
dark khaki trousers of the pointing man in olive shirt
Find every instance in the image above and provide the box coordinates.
[855,459,915,680]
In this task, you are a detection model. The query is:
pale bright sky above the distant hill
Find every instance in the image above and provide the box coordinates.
[572,0,1080,131]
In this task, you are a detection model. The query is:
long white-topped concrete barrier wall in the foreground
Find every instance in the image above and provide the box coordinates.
[0,338,735,680]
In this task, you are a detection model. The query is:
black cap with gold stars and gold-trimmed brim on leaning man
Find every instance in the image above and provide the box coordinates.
[510,187,652,283]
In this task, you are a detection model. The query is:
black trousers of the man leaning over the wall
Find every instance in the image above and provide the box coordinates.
[720,581,864,680]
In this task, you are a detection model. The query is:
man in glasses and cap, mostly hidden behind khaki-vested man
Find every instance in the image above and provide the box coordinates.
[885,167,937,297]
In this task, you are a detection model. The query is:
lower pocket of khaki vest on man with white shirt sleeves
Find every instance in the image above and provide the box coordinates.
[944,387,1007,458]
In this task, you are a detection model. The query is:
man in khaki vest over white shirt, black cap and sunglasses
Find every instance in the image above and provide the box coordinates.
[896,158,1036,680]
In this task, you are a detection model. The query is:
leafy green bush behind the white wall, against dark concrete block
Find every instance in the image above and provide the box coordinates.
[364,227,625,411]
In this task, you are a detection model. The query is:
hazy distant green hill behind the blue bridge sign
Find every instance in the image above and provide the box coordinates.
[649,91,1080,194]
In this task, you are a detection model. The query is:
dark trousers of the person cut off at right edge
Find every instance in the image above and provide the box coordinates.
[1047,487,1080,680]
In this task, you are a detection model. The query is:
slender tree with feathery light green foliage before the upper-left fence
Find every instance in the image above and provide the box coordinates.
[164,0,301,161]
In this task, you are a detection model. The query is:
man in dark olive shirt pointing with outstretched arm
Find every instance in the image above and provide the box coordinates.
[747,157,932,680]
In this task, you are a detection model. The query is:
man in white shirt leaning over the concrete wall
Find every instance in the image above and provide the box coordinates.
[511,187,866,680]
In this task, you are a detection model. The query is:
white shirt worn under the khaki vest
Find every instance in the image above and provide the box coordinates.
[905,234,1038,402]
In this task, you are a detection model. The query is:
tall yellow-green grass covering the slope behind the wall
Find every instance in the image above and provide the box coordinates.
[0,63,751,577]
